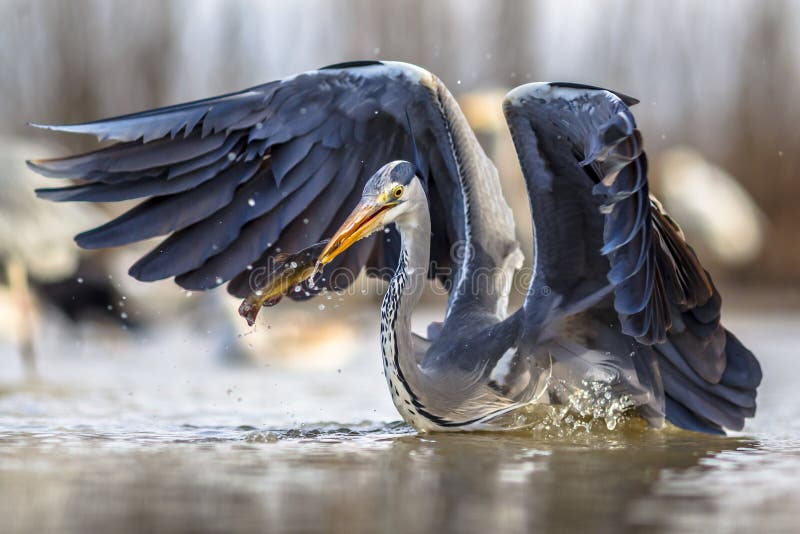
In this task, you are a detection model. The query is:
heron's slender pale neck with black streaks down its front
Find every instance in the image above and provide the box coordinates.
[381,201,431,427]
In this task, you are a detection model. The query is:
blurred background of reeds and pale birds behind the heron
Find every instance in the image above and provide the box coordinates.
[0,0,800,376]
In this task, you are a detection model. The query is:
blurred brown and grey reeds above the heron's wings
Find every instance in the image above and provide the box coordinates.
[0,0,800,284]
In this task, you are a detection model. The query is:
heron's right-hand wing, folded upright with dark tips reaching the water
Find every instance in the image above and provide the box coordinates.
[505,84,761,432]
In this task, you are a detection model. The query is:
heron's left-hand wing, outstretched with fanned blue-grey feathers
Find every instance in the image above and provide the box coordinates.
[30,62,464,296]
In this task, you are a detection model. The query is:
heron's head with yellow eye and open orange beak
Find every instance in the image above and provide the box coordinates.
[318,161,424,266]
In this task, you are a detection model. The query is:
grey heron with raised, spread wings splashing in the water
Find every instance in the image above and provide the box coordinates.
[30,61,761,433]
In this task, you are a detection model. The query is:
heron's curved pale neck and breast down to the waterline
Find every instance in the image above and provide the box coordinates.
[380,181,524,430]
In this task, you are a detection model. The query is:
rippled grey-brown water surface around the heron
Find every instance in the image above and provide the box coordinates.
[0,304,800,532]
